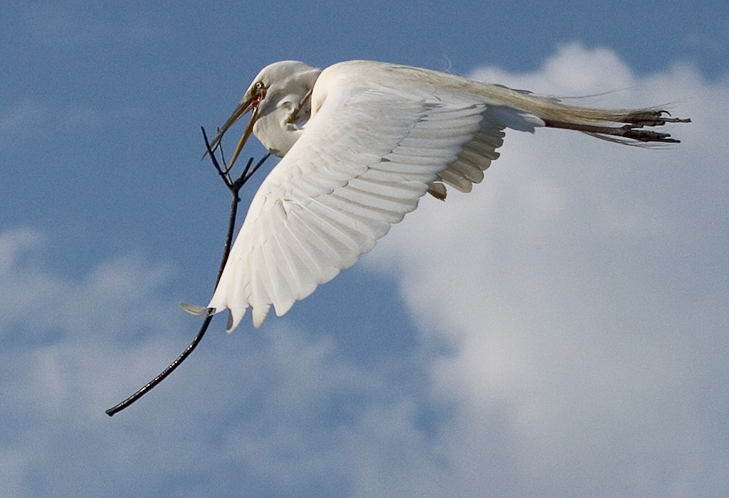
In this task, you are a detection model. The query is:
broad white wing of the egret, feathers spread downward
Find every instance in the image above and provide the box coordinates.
[208,64,535,331]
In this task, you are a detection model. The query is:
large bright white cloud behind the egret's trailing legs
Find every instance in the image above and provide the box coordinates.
[369,45,729,496]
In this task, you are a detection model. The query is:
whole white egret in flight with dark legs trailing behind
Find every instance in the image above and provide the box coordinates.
[202,61,690,332]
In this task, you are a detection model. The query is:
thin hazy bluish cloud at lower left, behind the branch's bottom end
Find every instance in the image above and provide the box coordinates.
[0,228,444,497]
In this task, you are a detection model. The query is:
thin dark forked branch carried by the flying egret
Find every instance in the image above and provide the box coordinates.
[106,128,270,417]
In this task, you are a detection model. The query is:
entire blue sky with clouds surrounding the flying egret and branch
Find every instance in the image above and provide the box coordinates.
[0,0,729,498]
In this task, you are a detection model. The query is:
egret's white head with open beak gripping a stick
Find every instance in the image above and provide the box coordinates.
[205,61,321,166]
